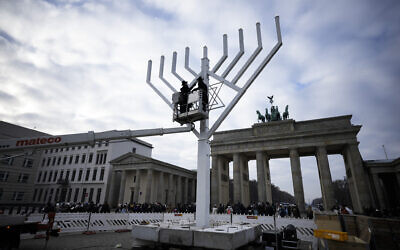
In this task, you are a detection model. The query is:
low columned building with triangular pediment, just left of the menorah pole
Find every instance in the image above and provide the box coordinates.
[108,153,196,207]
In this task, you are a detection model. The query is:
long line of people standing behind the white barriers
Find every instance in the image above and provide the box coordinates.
[0,199,400,219]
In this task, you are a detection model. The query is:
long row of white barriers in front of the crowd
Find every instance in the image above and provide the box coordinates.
[28,213,316,241]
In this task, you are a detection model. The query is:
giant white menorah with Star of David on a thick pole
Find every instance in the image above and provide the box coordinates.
[146,16,282,228]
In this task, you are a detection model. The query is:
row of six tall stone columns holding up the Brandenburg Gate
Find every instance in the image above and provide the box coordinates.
[211,145,370,212]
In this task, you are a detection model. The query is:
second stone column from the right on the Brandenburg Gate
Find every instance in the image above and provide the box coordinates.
[316,147,335,210]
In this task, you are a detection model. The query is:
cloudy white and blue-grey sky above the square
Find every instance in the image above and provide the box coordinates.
[0,0,400,202]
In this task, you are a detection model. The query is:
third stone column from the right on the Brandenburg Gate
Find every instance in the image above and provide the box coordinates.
[290,149,305,214]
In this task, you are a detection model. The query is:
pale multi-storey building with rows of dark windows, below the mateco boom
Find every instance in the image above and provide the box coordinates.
[32,139,153,204]
